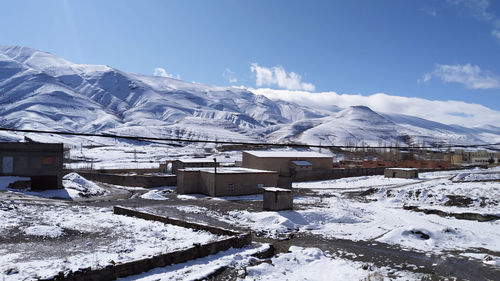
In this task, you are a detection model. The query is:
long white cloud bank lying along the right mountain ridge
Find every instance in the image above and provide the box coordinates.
[249,88,500,127]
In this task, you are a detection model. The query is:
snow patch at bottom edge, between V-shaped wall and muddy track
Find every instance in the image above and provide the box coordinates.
[118,244,424,281]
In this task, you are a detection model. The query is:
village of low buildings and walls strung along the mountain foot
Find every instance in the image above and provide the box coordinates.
[0,142,500,197]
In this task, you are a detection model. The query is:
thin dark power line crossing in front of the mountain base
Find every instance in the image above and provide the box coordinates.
[0,128,500,149]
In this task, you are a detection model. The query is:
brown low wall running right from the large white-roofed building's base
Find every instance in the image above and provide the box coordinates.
[293,167,385,182]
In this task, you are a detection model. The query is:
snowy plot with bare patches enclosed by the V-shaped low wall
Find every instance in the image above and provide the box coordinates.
[0,200,224,280]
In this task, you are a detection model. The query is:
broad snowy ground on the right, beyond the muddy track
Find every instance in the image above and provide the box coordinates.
[224,168,500,253]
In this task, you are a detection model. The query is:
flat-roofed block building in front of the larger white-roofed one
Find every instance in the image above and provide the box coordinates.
[177,167,278,197]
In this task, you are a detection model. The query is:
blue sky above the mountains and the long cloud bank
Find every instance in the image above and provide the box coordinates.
[0,0,500,115]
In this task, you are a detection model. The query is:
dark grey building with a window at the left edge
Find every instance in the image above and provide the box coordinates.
[0,142,64,189]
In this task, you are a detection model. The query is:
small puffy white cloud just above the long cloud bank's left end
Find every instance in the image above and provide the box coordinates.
[250,63,316,91]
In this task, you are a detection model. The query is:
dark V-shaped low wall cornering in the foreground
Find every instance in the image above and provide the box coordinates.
[44,206,252,281]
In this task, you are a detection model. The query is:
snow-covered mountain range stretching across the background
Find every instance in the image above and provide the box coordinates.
[0,46,500,145]
